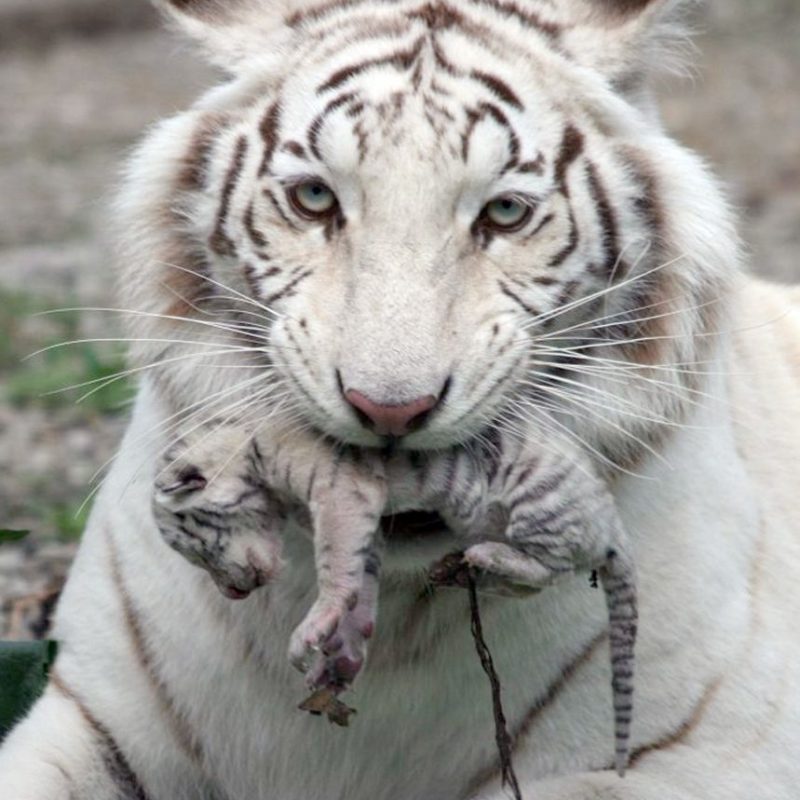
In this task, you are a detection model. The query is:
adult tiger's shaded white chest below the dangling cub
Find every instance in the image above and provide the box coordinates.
[122,512,612,800]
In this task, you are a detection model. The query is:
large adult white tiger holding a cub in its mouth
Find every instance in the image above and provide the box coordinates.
[0,0,800,800]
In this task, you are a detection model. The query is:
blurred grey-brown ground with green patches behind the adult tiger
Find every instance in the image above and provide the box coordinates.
[0,0,800,638]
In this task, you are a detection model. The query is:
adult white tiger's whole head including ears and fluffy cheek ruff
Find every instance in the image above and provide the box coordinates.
[121,0,735,462]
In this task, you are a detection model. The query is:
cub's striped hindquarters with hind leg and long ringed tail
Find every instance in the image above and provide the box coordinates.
[436,441,637,774]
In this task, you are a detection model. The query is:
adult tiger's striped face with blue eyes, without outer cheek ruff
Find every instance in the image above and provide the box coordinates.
[126,0,736,462]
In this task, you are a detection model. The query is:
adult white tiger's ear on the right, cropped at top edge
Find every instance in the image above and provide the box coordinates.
[564,0,697,93]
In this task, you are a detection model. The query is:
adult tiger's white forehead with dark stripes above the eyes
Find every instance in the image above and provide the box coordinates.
[262,4,563,183]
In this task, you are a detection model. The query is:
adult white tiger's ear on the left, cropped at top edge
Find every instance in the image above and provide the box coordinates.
[152,0,295,73]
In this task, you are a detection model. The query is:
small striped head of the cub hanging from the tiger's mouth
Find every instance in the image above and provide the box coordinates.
[153,425,283,599]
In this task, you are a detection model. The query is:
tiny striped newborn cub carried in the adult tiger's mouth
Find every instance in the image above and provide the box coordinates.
[153,424,637,772]
